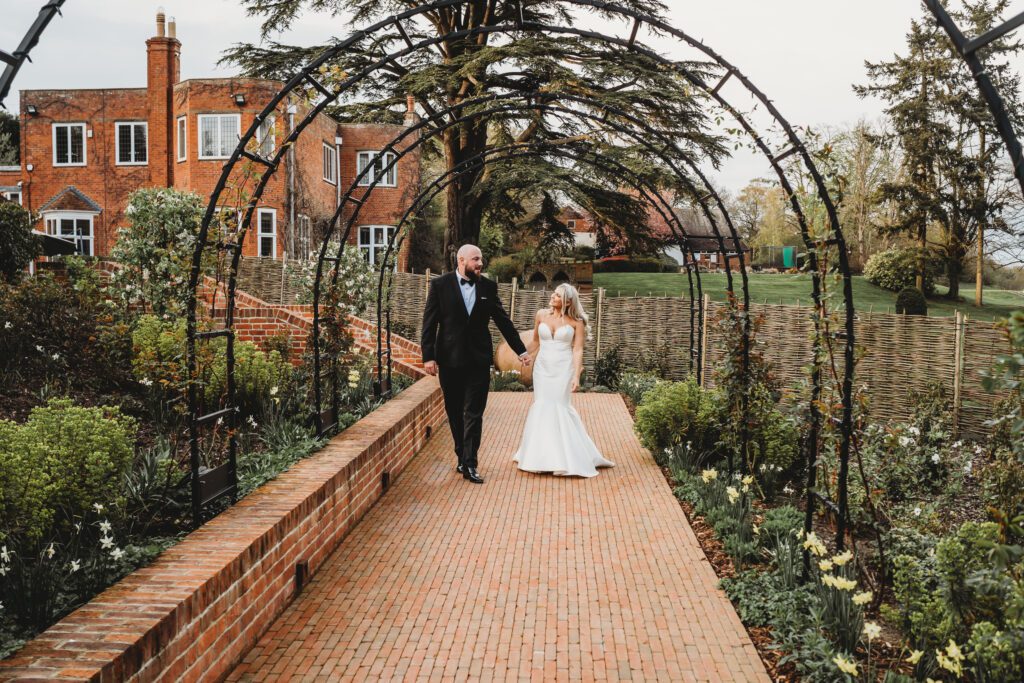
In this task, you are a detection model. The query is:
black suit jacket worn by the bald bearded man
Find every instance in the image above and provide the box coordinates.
[420,271,526,368]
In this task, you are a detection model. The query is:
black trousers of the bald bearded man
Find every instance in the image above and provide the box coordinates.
[438,366,490,468]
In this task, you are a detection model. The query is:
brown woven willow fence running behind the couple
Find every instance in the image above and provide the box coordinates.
[239,259,1008,436]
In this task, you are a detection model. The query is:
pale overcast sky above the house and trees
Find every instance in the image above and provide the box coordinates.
[0,0,1024,189]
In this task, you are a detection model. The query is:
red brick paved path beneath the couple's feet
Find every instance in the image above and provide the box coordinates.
[228,393,768,681]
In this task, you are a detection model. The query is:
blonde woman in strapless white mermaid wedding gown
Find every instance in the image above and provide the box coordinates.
[512,284,614,477]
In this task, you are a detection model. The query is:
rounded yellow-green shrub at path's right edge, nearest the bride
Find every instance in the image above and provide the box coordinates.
[636,378,720,458]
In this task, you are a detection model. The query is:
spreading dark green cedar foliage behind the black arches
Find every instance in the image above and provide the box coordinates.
[224,0,724,267]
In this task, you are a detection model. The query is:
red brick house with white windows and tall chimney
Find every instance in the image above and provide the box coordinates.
[0,14,420,268]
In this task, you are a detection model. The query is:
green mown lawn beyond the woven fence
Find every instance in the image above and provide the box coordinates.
[594,272,1024,319]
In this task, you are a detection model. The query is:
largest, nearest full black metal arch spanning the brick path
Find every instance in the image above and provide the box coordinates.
[186,0,855,549]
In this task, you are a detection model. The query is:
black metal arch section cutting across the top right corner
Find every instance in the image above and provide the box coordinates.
[925,0,1024,194]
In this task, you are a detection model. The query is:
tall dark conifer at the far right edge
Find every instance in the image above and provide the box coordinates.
[855,0,1024,299]
